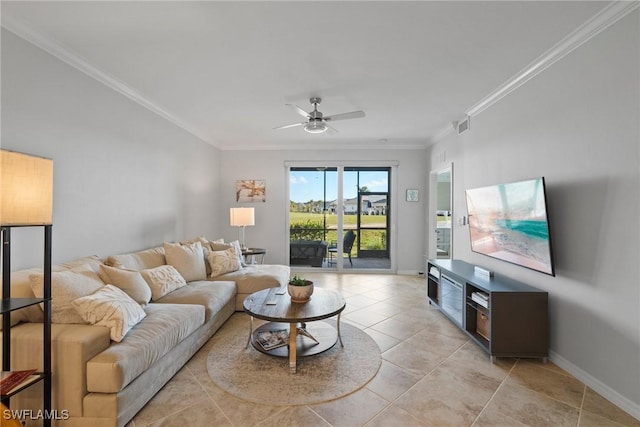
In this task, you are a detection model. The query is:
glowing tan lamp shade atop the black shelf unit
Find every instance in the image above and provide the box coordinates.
[0,150,53,225]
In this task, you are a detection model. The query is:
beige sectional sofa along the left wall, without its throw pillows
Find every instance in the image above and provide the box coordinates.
[3,241,290,427]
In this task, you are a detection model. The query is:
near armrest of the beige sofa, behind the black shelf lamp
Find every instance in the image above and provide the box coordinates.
[1,323,111,416]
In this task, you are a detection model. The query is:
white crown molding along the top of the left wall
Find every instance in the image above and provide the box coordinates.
[2,11,217,146]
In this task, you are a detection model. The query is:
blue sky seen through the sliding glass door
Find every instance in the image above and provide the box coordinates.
[289,171,389,202]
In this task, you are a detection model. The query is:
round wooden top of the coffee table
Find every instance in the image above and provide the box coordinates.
[243,287,346,323]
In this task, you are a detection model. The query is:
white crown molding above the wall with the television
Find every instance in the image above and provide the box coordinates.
[464,0,640,118]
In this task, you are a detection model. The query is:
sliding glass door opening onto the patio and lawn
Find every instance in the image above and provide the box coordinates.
[288,166,391,270]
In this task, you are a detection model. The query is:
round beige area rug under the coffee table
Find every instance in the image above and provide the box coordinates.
[207,318,381,406]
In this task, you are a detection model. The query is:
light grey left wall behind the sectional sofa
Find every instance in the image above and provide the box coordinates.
[2,30,220,270]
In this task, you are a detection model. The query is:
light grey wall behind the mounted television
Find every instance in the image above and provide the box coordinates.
[431,11,640,418]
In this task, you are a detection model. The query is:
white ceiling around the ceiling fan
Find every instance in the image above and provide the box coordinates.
[1,1,610,149]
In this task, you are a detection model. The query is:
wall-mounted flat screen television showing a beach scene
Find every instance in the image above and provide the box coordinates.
[466,178,555,276]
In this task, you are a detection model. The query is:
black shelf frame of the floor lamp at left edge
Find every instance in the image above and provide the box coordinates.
[0,224,53,426]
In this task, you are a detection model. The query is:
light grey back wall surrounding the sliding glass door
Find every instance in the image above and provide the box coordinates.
[219,149,427,273]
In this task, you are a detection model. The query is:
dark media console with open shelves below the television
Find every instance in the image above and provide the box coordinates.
[427,260,549,363]
